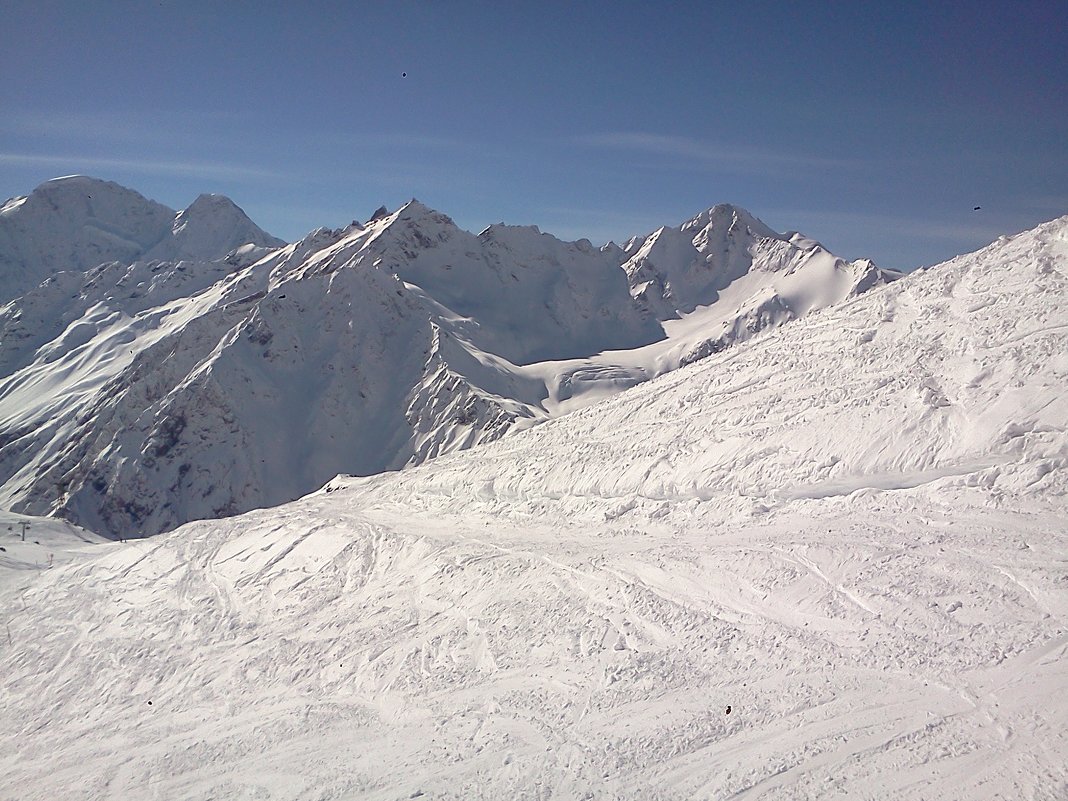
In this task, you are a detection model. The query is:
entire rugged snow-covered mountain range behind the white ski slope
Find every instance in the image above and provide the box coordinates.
[0,178,896,535]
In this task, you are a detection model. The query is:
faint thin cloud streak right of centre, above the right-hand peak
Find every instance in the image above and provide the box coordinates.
[574,131,859,173]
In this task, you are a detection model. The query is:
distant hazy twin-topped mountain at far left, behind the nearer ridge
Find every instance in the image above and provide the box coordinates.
[0,175,283,303]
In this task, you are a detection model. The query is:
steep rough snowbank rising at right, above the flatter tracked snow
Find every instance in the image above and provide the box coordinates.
[391,218,1068,514]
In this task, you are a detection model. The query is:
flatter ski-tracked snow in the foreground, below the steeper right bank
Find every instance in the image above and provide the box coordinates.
[0,490,1068,799]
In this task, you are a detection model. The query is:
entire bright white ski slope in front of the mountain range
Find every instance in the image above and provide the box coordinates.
[0,218,1068,800]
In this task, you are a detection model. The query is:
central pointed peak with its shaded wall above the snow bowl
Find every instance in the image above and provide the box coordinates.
[290,200,662,364]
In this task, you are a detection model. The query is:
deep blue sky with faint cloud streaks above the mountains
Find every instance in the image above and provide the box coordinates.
[0,0,1068,269]
